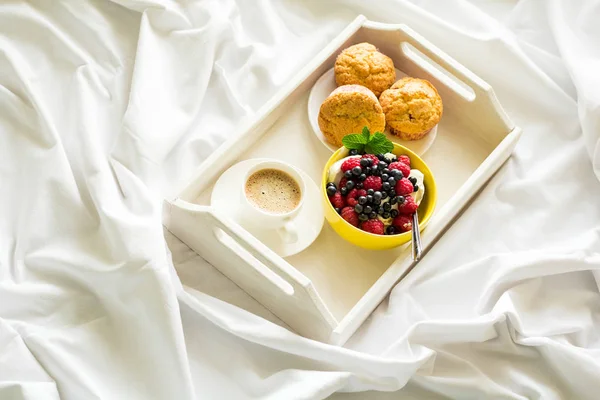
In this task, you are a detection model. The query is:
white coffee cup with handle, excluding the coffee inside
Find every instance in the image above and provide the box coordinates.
[241,160,306,243]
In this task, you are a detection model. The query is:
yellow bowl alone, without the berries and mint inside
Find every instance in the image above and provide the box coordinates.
[321,143,437,250]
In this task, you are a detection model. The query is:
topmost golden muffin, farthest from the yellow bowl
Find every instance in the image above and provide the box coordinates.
[334,43,396,97]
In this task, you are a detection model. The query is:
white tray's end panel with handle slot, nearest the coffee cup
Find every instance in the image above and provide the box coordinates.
[163,198,337,341]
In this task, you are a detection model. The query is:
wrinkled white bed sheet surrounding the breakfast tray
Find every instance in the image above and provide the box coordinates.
[0,0,600,400]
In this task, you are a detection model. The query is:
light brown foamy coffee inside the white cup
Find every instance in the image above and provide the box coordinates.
[244,168,302,214]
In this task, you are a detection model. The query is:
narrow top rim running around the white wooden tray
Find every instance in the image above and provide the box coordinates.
[164,15,522,345]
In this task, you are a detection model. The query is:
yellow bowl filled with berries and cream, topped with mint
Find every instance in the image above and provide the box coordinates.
[321,128,437,250]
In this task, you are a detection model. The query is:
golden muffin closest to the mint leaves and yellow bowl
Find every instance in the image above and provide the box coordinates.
[319,85,385,147]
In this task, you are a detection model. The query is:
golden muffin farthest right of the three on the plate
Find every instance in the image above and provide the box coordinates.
[379,77,443,140]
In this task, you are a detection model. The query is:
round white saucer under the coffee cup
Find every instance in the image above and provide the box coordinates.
[210,158,325,257]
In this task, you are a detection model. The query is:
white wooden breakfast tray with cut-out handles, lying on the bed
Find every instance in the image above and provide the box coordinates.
[164,16,521,345]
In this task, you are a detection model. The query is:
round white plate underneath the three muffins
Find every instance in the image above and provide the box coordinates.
[308,68,437,155]
